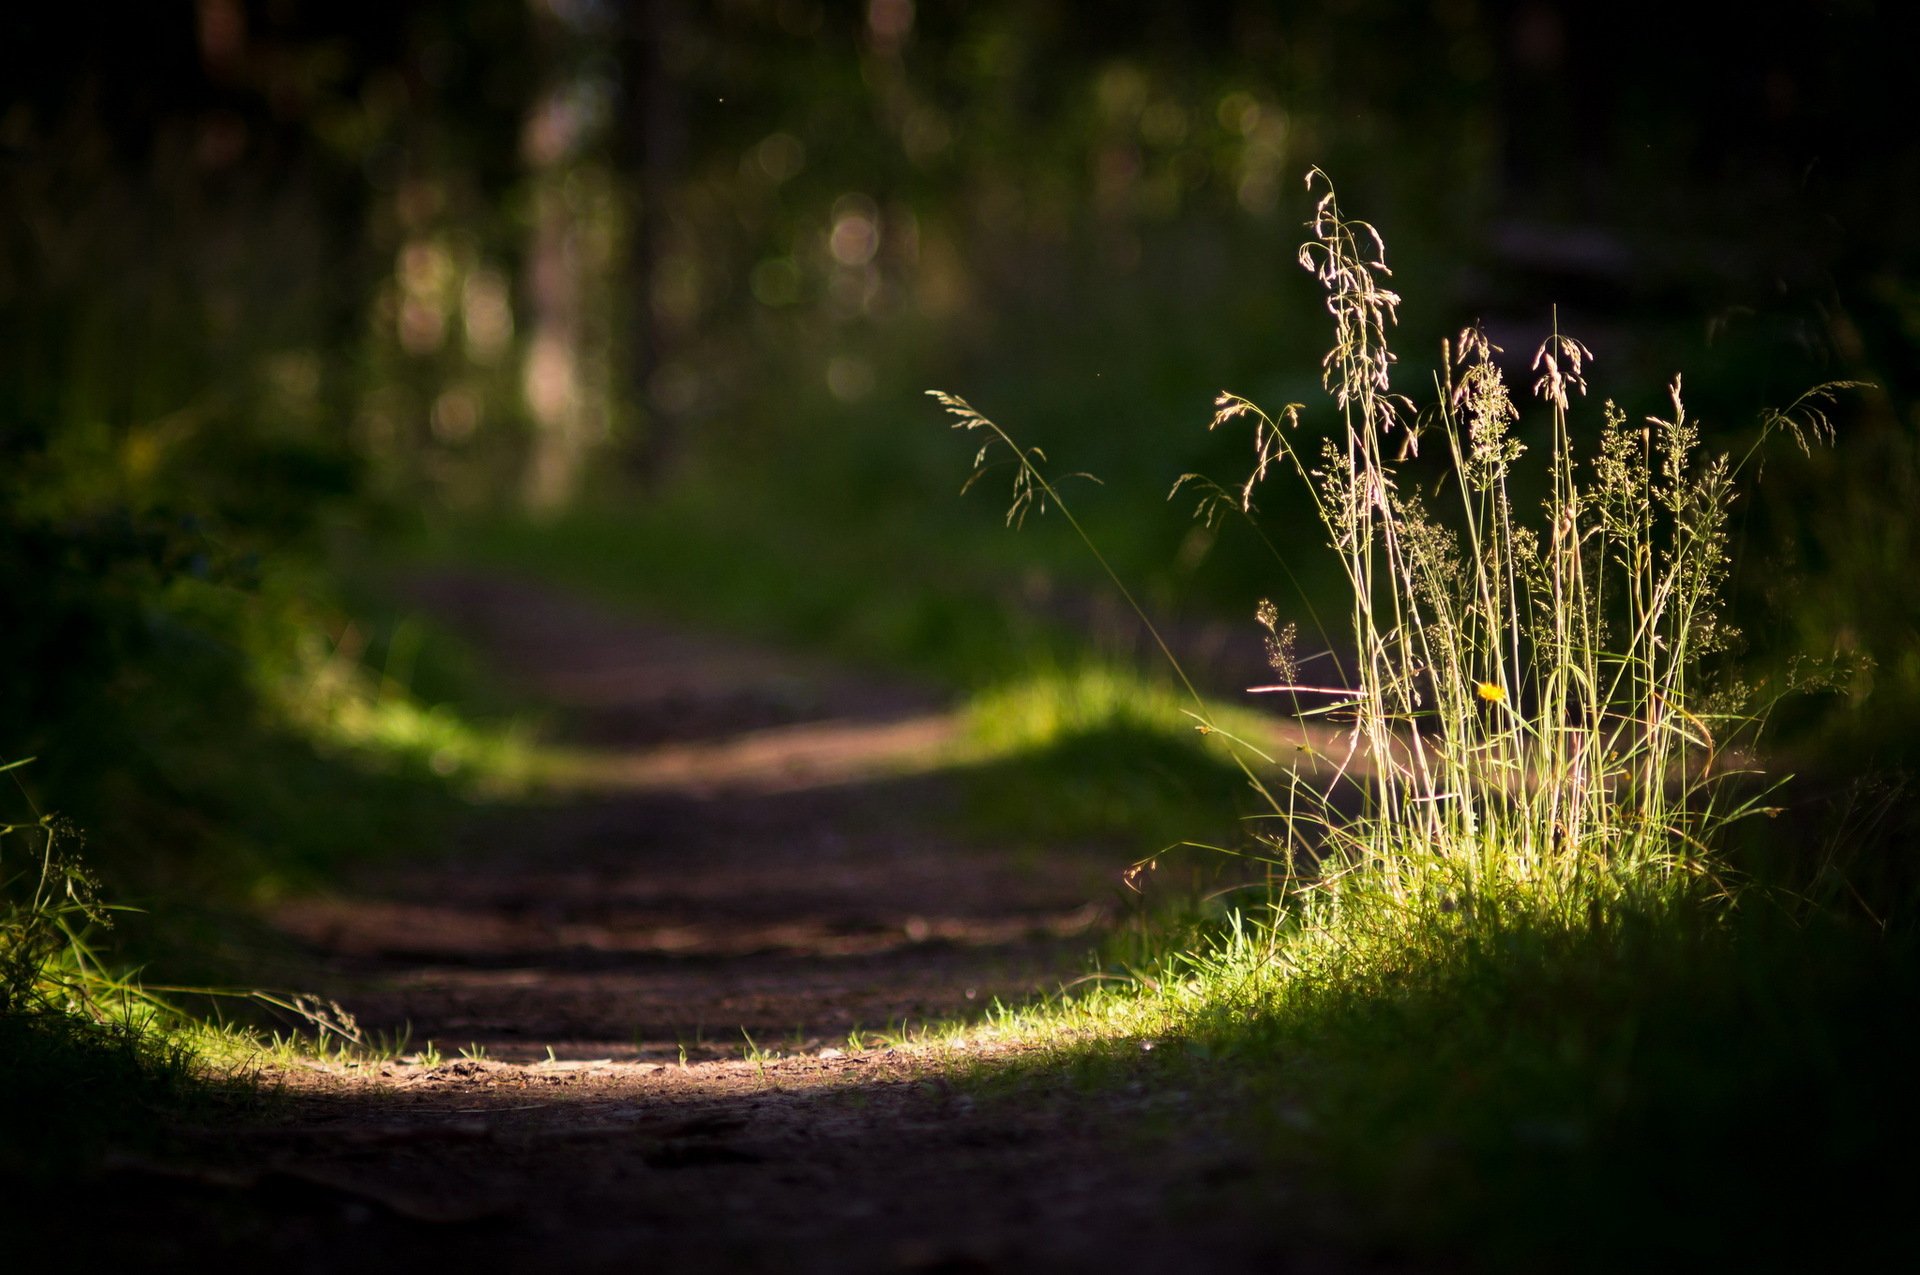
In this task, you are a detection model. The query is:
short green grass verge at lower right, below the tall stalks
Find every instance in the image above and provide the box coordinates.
[952,901,1920,1269]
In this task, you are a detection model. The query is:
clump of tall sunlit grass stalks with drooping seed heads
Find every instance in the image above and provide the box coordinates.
[937,169,1837,939]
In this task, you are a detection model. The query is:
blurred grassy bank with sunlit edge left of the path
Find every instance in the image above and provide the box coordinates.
[0,565,532,910]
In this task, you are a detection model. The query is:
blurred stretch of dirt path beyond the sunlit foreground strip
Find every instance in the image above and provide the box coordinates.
[264,572,1117,1064]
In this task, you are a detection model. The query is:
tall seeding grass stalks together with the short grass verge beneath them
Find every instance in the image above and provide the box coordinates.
[917,174,1920,1269]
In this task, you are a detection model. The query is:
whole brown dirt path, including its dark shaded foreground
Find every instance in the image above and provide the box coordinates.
[90,574,1344,1271]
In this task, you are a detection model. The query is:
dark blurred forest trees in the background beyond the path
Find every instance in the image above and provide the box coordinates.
[11,0,1920,518]
